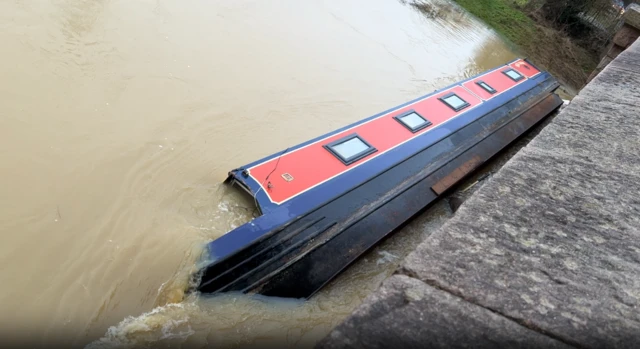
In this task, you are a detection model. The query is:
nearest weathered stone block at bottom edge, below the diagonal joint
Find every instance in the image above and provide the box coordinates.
[317,275,569,349]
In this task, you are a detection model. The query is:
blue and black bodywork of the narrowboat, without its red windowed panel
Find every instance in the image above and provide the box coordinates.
[197,67,562,298]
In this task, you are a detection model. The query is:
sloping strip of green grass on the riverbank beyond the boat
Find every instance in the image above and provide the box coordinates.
[454,0,599,89]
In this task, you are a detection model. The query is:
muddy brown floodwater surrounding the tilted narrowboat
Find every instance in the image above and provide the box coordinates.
[0,0,516,348]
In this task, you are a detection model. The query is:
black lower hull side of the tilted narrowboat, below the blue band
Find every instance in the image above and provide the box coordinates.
[198,76,562,298]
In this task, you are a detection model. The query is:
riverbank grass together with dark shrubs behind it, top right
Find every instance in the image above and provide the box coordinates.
[455,0,631,89]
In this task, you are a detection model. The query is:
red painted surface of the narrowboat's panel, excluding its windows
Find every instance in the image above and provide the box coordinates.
[249,58,537,203]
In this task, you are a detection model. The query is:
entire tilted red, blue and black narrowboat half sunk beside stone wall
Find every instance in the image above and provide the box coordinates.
[197,59,562,298]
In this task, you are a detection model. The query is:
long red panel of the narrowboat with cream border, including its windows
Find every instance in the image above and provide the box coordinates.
[247,60,540,204]
